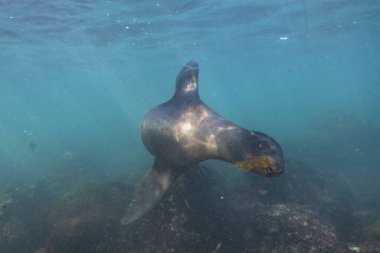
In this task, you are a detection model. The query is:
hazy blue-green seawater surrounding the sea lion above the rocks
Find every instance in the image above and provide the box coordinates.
[0,0,380,252]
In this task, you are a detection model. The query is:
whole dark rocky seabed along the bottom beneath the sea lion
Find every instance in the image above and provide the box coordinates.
[0,162,377,253]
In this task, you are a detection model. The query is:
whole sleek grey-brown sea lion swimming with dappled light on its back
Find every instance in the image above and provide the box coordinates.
[121,61,284,225]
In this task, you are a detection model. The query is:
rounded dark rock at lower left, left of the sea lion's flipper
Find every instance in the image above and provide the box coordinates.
[45,183,132,253]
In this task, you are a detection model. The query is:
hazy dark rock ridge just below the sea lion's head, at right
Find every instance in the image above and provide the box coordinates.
[245,160,361,238]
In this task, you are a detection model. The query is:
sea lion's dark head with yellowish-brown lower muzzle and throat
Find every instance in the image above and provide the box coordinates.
[233,132,284,177]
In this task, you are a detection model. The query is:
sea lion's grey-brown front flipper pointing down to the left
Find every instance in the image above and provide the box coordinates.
[121,158,179,225]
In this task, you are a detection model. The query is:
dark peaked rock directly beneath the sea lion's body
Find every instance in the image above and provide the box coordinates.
[120,167,228,252]
